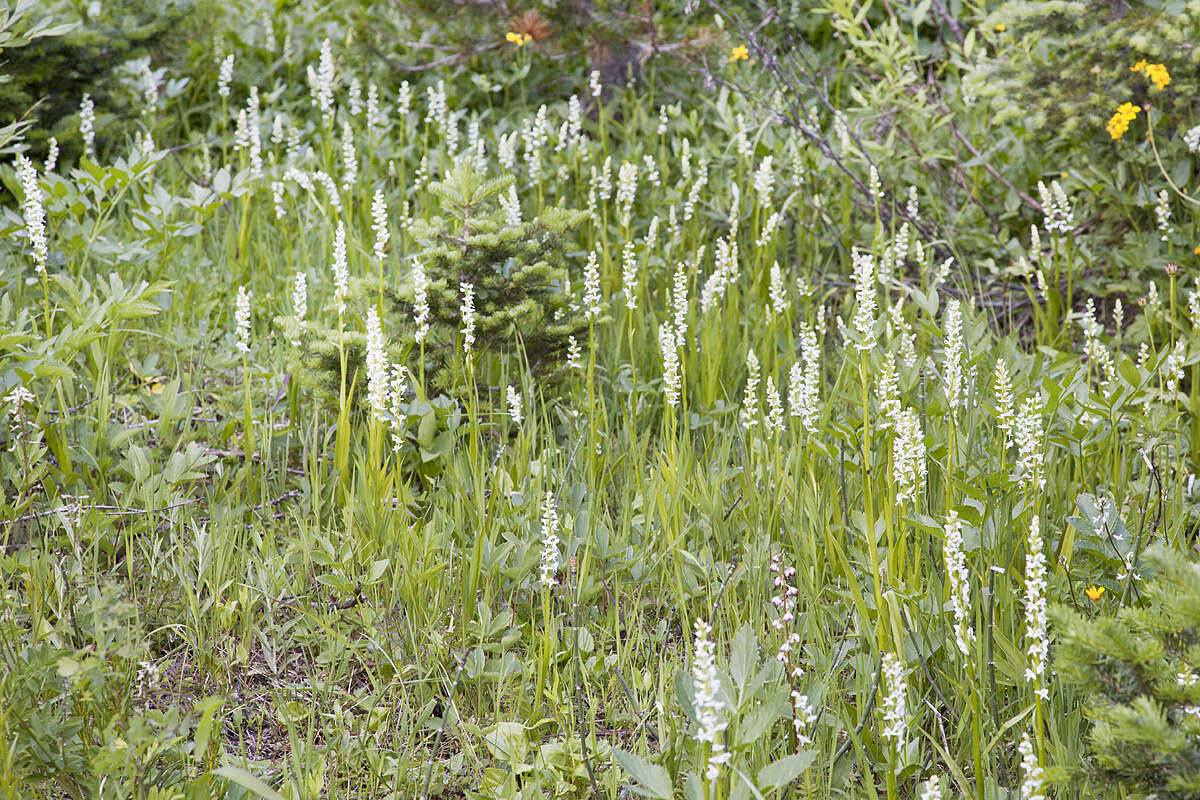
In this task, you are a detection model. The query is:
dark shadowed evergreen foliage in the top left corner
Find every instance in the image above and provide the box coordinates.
[0,0,193,157]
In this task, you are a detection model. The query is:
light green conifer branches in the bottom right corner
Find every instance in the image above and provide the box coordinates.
[1054,549,1200,800]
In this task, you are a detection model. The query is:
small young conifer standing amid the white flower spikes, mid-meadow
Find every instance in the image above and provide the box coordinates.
[290,164,588,407]
